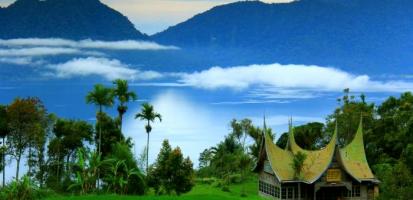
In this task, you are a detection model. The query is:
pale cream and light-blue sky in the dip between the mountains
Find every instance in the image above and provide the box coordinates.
[0,0,291,35]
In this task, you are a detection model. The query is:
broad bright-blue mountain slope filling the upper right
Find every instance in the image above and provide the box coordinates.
[152,0,413,73]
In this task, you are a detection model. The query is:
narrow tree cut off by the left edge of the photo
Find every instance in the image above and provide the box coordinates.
[0,105,9,187]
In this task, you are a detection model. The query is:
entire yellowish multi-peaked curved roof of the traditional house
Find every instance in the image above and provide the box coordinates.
[254,118,378,184]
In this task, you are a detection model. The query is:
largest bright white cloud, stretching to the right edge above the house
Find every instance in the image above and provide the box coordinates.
[179,64,413,93]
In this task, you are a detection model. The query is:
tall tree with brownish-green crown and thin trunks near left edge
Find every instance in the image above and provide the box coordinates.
[7,97,46,181]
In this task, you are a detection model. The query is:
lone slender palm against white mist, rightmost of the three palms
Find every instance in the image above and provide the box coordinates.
[135,103,162,174]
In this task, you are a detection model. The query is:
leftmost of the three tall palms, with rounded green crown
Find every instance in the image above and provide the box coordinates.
[86,84,113,153]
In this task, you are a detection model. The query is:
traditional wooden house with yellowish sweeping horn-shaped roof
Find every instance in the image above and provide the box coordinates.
[254,121,379,200]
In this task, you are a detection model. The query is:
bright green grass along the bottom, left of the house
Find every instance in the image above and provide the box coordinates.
[47,179,263,200]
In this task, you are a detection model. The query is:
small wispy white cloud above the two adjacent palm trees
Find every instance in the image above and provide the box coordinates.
[48,57,162,80]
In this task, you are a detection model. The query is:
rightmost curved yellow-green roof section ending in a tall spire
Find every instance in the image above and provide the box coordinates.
[339,120,377,182]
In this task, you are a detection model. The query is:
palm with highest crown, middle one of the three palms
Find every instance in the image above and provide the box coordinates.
[113,79,138,132]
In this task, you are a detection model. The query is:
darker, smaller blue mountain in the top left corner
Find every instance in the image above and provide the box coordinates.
[0,0,148,40]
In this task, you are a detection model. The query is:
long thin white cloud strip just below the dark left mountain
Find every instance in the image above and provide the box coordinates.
[0,38,178,50]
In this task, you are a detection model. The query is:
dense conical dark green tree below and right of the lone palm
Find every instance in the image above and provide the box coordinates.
[148,140,195,195]
